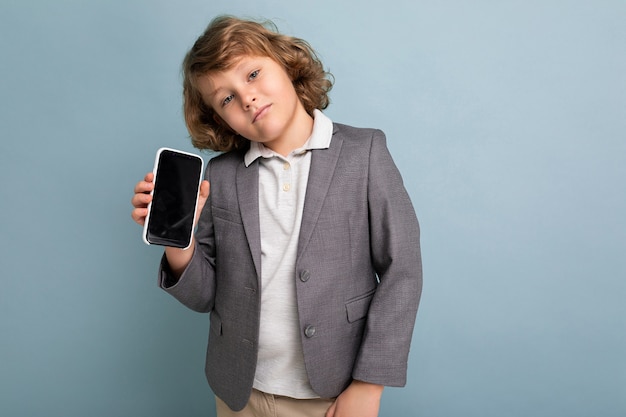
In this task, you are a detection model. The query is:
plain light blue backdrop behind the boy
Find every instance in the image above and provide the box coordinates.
[0,0,626,417]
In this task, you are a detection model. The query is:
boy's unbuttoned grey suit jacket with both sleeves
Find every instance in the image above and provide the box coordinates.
[160,124,422,410]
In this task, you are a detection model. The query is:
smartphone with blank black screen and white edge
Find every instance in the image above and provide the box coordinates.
[143,148,204,249]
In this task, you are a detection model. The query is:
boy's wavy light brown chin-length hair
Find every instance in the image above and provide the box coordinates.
[183,16,333,152]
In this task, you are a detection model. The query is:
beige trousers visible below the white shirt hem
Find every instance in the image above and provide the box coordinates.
[215,389,334,417]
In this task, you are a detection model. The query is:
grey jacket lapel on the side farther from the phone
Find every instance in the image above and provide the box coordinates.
[298,126,343,257]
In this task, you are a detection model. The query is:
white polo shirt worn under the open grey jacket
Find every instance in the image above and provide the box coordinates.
[244,110,333,399]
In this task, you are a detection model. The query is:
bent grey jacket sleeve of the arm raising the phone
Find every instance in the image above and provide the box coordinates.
[159,161,215,313]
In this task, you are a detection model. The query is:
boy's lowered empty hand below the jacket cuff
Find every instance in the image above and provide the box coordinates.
[326,380,383,417]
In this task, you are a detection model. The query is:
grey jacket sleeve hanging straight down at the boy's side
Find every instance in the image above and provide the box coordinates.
[353,131,422,386]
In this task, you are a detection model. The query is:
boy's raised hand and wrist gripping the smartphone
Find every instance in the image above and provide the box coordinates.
[131,172,210,278]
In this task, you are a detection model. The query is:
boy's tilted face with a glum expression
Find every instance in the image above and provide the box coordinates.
[198,56,313,154]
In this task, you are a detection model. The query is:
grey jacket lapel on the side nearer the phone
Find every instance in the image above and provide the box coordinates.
[237,159,261,280]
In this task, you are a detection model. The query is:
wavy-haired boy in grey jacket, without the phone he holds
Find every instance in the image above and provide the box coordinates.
[133,17,422,417]
